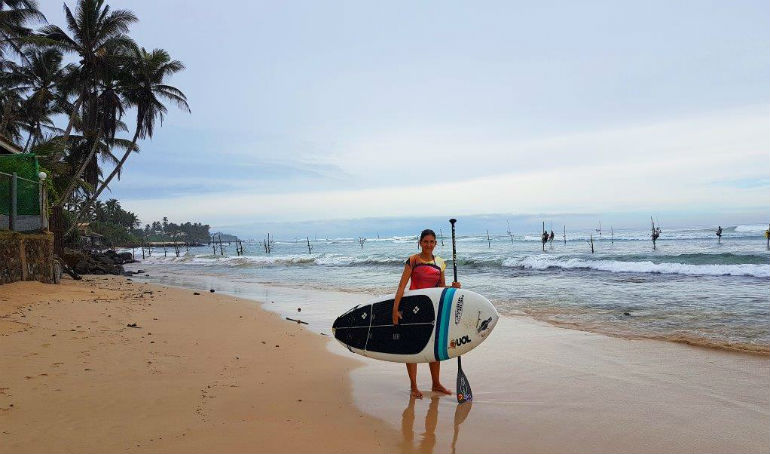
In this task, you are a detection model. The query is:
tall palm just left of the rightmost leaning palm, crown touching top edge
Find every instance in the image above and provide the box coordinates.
[41,0,137,206]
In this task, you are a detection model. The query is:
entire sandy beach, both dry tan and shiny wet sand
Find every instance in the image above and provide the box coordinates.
[0,274,770,453]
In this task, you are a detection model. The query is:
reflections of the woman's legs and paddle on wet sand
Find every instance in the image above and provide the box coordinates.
[401,395,473,454]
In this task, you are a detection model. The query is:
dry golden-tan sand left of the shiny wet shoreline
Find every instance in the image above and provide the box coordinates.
[0,277,398,453]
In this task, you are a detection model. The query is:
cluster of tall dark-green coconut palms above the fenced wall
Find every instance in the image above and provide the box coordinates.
[0,0,190,245]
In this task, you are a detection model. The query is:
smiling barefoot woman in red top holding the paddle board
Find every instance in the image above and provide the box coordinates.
[393,229,461,399]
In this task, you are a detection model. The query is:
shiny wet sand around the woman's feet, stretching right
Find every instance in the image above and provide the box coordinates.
[350,317,770,453]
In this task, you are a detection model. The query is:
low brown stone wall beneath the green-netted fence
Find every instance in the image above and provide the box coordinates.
[0,230,54,284]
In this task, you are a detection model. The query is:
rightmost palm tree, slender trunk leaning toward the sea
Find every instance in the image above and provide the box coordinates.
[68,47,190,231]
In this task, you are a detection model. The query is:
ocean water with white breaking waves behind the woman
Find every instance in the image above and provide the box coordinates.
[126,225,770,355]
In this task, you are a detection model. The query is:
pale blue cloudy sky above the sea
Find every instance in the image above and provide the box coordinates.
[41,0,770,238]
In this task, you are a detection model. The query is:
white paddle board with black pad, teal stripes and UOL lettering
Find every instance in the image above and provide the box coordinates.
[332,288,499,363]
